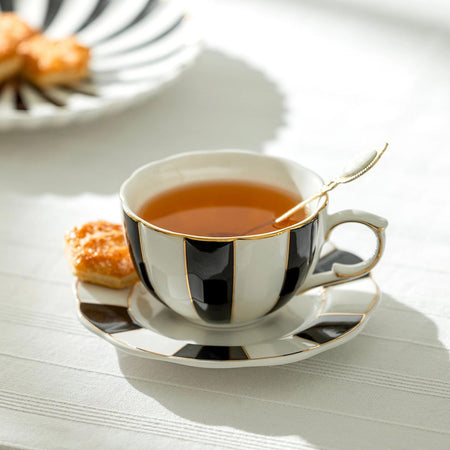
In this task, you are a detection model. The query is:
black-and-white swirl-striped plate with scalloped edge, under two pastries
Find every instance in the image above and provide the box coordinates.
[0,0,201,129]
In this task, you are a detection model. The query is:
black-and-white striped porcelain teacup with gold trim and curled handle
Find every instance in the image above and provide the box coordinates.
[120,150,387,327]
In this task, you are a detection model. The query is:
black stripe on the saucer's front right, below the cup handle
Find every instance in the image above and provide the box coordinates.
[296,314,363,344]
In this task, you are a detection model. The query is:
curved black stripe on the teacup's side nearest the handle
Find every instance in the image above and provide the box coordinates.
[267,219,317,314]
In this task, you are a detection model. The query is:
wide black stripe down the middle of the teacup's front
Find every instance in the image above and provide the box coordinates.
[185,238,234,323]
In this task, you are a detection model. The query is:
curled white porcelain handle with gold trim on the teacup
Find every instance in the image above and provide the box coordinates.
[300,209,388,292]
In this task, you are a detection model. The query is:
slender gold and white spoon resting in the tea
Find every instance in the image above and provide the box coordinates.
[245,143,389,235]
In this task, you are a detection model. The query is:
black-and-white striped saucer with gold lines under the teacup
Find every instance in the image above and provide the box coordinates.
[75,249,380,368]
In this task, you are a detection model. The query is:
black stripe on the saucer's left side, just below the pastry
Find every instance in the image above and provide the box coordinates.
[80,302,142,333]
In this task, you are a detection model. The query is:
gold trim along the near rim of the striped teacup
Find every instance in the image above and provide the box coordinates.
[123,195,328,242]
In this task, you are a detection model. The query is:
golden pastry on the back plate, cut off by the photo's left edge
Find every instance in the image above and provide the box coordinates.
[0,12,36,83]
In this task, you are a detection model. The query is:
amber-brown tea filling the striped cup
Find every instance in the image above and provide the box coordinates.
[139,180,308,237]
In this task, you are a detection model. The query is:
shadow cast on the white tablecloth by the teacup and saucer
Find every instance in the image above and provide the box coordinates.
[118,295,449,448]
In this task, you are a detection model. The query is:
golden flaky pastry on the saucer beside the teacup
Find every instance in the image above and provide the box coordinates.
[64,220,138,289]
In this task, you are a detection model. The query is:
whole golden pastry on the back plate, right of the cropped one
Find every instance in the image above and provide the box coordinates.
[17,35,90,87]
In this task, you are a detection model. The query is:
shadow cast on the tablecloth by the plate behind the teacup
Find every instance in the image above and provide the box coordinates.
[0,50,283,194]
